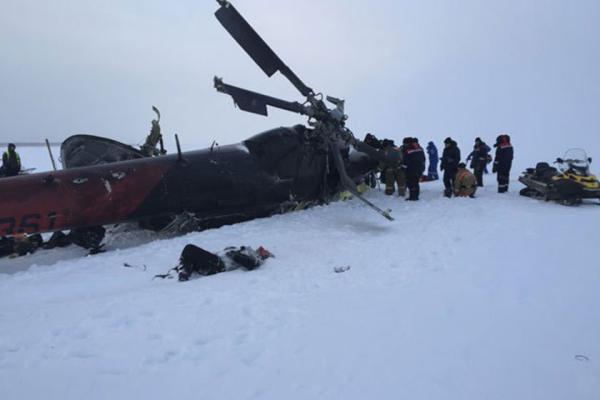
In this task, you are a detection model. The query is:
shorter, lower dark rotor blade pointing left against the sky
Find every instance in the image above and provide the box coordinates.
[215,77,312,116]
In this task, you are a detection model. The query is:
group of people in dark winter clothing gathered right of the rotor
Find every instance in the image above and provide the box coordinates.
[365,134,514,201]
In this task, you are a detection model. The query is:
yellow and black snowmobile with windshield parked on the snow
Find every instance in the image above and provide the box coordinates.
[519,149,600,205]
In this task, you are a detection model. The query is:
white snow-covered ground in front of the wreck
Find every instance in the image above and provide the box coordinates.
[0,148,600,400]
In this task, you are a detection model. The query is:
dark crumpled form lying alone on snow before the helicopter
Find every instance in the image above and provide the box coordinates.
[156,244,274,281]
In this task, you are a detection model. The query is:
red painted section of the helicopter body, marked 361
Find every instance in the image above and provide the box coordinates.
[0,157,172,236]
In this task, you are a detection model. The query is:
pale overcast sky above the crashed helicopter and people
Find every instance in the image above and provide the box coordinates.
[0,0,600,169]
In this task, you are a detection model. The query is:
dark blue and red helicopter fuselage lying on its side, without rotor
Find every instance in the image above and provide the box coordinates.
[0,127,373,236]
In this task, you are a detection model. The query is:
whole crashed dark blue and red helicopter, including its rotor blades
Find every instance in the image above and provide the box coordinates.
[0,0,397,250]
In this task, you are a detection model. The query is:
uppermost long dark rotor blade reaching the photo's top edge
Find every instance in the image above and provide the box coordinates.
[215,0,313,97]
